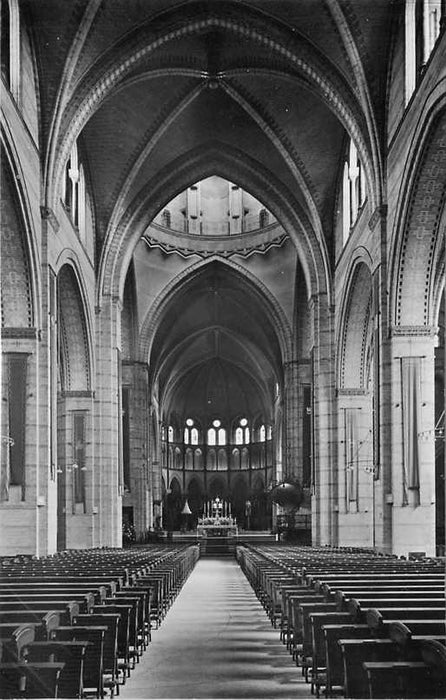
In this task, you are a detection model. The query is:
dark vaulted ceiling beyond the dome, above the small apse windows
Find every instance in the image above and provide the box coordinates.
[149,263,282,418]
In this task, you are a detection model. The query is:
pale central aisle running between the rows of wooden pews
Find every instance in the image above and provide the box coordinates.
[120,559,311,700]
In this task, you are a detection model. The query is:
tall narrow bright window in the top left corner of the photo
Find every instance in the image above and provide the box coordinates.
[0,0,20,101]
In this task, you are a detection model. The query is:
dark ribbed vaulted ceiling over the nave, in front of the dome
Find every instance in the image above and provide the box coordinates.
[25,0,391,252]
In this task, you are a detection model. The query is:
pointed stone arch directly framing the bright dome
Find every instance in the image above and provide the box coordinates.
[97,142,331,312]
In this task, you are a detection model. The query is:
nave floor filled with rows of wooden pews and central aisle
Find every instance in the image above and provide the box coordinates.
[0,542,446,700]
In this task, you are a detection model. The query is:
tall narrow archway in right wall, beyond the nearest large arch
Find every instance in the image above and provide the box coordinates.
[337,258,378,546]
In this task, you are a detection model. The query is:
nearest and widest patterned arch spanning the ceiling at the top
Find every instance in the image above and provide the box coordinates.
[46,1,379,223]
